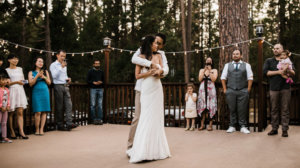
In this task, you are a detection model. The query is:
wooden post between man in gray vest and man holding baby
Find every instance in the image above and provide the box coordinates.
[257,39,266,132]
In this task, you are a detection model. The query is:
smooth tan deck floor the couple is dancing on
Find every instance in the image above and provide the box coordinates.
[0,124,300,168]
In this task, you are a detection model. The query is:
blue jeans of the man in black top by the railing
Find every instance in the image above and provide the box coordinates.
[90,88,103,121]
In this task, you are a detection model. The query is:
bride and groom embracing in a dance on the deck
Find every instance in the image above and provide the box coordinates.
[126,33,171,163]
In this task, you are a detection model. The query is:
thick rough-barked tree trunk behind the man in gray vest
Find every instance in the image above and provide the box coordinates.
[219,0,249,72]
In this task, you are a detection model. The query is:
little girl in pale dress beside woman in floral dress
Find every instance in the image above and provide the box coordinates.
[185,83,197,131]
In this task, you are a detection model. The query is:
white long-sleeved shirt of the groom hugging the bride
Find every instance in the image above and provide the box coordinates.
[131,49,169,91]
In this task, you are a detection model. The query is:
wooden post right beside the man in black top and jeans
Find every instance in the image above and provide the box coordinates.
[103,46,110,122]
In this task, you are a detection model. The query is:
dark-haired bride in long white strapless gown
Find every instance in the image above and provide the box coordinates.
[126,36,171,163]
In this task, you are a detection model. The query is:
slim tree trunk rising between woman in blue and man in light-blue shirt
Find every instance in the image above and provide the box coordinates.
[44,0,52,69]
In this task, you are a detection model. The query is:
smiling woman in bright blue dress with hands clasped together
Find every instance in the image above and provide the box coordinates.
[28,57,51,135]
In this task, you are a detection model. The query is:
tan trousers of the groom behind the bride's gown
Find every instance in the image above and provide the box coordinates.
[127,91,141,149]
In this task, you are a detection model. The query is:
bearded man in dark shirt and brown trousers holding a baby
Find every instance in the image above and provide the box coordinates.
[263,44,295,137]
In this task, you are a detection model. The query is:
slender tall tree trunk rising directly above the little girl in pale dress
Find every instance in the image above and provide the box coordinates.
[180,0,189,83]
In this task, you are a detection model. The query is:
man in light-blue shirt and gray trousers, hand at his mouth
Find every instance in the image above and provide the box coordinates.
[50,50,77,131]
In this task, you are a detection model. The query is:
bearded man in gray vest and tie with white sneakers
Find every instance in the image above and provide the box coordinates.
[221,49,253,134]
